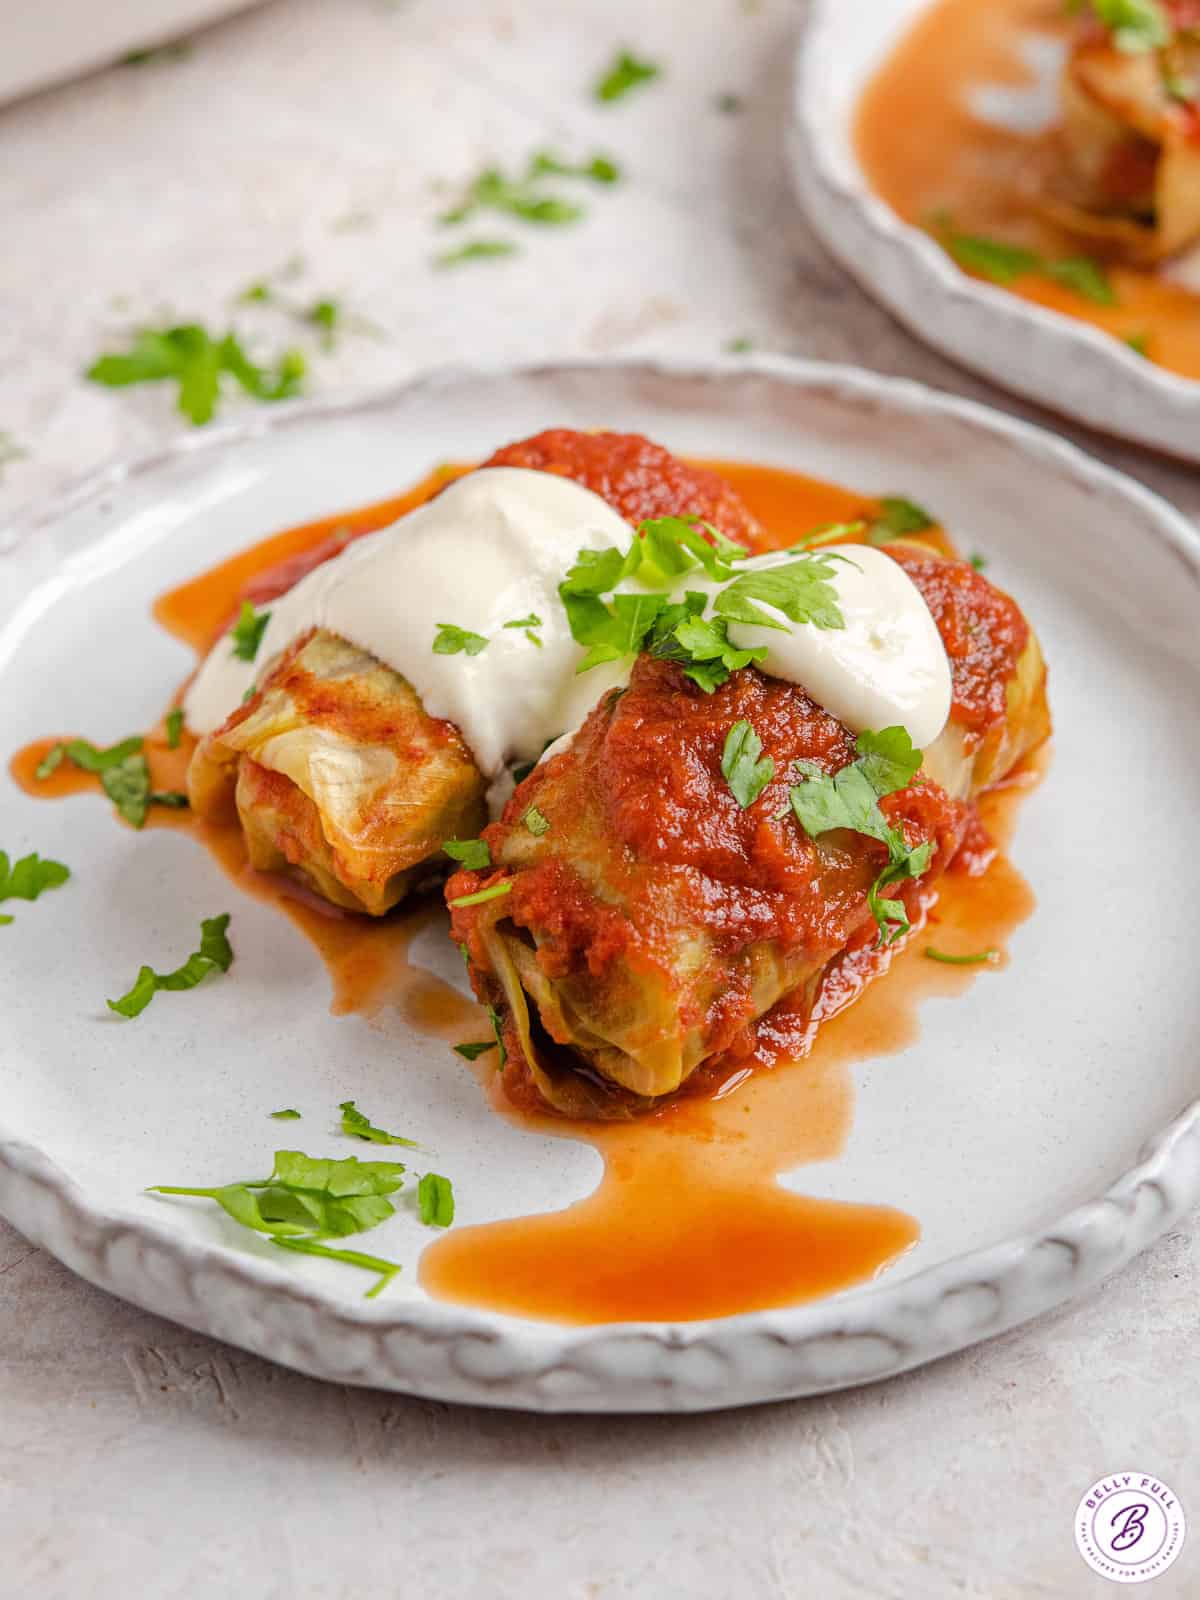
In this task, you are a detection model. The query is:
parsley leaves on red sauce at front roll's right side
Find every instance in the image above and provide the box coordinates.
[790,726,933,944]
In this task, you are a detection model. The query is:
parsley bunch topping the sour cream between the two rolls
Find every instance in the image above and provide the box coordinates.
[558,517,845,694]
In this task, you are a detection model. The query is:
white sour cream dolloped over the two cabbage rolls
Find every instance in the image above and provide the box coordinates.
[184,467,950,786]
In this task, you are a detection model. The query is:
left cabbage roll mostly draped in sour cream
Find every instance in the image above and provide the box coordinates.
[187,429,758,917]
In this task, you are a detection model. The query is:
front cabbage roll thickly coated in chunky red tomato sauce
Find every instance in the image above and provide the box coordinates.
[446,542,1050,1117]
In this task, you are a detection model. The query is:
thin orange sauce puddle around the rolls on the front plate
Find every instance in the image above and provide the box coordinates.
[11,462,1035,1323]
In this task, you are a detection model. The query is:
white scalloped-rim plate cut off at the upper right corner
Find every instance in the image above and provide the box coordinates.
[790,0,1200,461]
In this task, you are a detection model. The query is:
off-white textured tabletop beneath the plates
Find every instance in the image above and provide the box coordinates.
[0,0,1200,1600]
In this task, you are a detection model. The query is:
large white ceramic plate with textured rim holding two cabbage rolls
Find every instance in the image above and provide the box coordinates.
[0,358,1200,1410]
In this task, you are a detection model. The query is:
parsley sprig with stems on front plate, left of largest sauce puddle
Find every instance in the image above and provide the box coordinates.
[149,1150,405,1298]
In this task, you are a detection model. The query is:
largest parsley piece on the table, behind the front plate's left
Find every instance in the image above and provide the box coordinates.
[83,323,306,427]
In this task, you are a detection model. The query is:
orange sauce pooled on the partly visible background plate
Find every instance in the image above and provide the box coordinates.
[856,0,1200,378]
